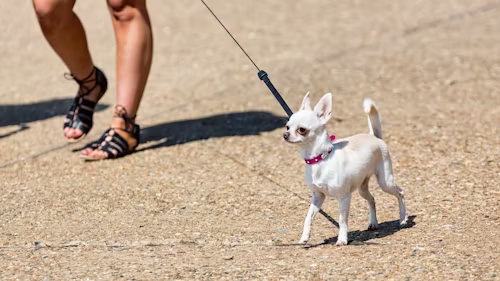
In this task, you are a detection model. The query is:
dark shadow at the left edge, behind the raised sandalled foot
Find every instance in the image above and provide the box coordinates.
[0,98,109,138]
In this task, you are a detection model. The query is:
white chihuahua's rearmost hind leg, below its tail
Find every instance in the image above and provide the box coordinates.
[375,153,408,226]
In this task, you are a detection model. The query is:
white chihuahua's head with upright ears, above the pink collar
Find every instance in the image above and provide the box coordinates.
[283,92,332,144]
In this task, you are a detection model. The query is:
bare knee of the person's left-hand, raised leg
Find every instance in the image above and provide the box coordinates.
[33,0,74,29]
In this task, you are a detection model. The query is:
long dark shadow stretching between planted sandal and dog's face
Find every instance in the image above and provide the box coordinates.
[138,111,288,151]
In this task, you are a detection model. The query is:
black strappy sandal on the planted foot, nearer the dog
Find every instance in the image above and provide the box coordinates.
[80,105,141,161]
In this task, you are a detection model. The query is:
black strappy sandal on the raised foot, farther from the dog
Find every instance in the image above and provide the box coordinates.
[63,66,108,142]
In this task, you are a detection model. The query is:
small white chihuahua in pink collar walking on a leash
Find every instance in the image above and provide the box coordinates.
[283,93,408,246]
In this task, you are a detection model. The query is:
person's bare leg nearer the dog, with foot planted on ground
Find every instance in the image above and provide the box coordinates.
[82,0,153,159]
